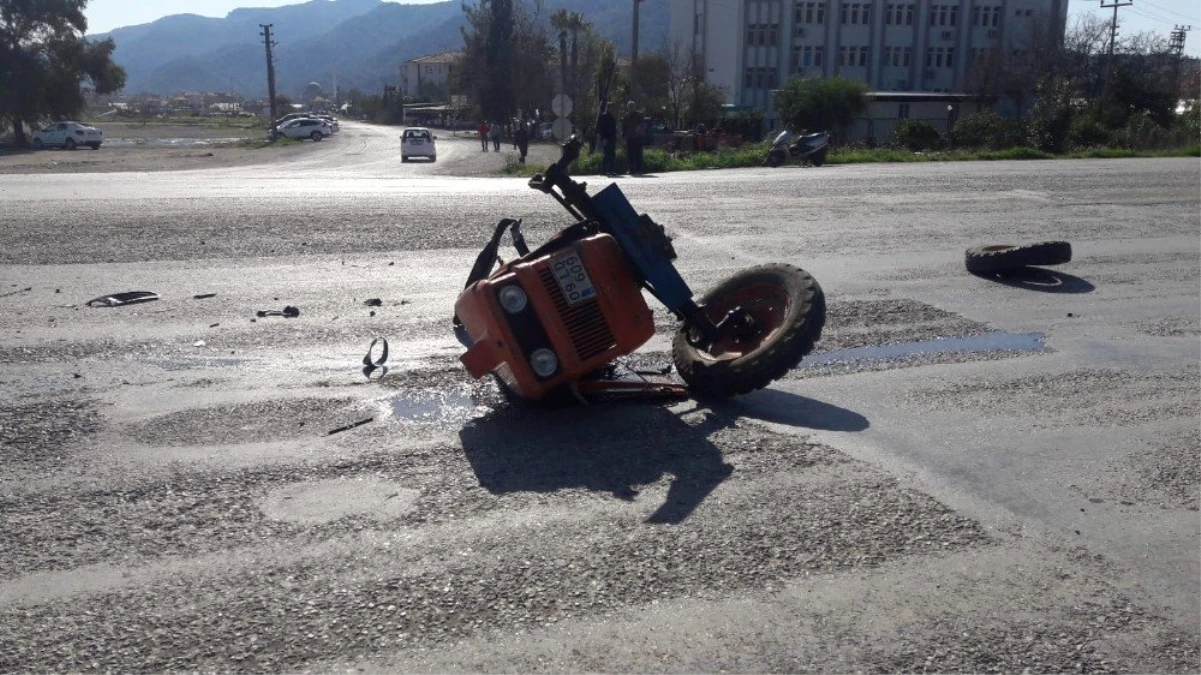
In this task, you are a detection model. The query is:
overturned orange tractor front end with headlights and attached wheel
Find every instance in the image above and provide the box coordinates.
[455,137,825,400]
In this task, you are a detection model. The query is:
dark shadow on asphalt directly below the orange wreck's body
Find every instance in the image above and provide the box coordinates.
[459,404,733,524]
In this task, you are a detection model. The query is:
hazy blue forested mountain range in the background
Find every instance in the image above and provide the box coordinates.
[88,0,668,96]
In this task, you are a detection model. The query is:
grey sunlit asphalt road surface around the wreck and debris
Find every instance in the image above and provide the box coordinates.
[0,125,1201,673]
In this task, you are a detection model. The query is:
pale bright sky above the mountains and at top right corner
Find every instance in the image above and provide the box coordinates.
[86,0,1201,56]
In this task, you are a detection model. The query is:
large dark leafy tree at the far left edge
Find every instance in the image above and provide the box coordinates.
[0,0,125,145]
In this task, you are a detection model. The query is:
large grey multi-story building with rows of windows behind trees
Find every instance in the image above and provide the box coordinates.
[670,0,1068,131]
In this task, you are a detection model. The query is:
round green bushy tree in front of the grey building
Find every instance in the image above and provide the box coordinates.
[776,77,867,136]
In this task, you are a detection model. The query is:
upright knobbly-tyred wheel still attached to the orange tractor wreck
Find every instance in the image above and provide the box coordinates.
[671,264,826,398]
